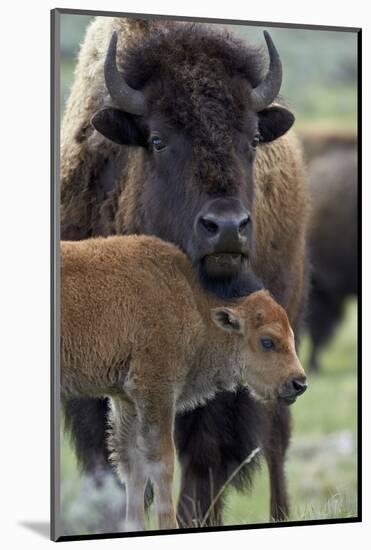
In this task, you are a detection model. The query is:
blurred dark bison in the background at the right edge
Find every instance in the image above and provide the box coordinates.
[307,145,358,372]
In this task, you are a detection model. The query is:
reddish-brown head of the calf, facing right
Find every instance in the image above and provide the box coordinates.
[212,290,307,404]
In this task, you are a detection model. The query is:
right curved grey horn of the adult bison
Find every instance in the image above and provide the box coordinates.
[251,31,282,112]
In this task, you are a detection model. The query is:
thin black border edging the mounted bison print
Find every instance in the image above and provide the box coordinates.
[50,8,362,542]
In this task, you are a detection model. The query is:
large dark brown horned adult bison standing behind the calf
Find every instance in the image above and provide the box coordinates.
[61,18,307,526]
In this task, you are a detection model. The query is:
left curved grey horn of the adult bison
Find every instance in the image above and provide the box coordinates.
[104,32,146,115]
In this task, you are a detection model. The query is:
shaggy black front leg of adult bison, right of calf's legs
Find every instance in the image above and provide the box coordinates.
[175,390,263,527]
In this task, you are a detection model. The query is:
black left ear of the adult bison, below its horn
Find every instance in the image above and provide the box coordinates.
[91,107,146,147]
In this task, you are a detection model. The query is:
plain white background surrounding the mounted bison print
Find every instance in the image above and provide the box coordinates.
[0,0,371,550]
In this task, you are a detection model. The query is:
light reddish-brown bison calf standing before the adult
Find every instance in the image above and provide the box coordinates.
[61,236,304,530]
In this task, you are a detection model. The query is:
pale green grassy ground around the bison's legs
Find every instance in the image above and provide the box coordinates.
[61,300,357,534]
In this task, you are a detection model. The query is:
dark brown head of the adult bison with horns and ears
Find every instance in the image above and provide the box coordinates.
[92,25,294,293]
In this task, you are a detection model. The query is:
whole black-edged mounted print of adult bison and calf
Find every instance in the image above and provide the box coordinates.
[51,9,362,541]
